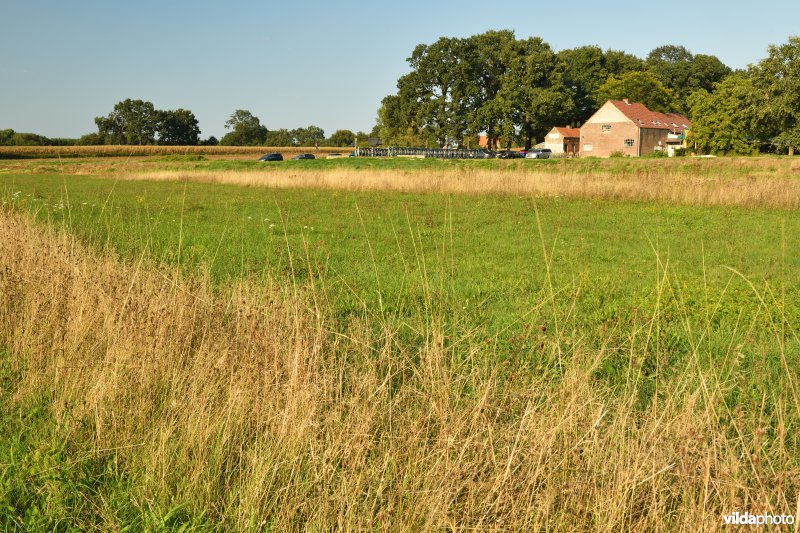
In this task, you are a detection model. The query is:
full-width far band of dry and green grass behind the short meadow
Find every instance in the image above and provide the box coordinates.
[0,153,800,209]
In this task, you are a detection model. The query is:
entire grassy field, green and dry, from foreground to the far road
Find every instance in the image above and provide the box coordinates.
[0,156,800,530]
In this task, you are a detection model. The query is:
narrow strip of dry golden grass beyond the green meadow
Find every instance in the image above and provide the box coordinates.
[133,163,800,208]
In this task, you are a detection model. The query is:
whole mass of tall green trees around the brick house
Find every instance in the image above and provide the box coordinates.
[376,30,800,154]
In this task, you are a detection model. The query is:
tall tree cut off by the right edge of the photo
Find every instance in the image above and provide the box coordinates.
[753,37,800,155]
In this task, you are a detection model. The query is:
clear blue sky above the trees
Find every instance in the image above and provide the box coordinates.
[0,0,800,137]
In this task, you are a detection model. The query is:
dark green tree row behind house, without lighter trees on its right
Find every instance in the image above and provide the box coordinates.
[377,30,731,148]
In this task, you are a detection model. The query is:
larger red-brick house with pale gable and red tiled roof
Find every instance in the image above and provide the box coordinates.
[580,99,692,157]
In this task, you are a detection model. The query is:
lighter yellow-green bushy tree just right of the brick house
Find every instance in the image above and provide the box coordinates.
[688,73,760,155]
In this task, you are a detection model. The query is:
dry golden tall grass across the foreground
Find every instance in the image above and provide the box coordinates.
[0,215,800,531]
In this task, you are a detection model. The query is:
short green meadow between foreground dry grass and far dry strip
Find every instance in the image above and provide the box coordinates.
[2,170,800,366]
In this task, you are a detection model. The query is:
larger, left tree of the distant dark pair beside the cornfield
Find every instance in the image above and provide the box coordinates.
[94,98,160,144]
